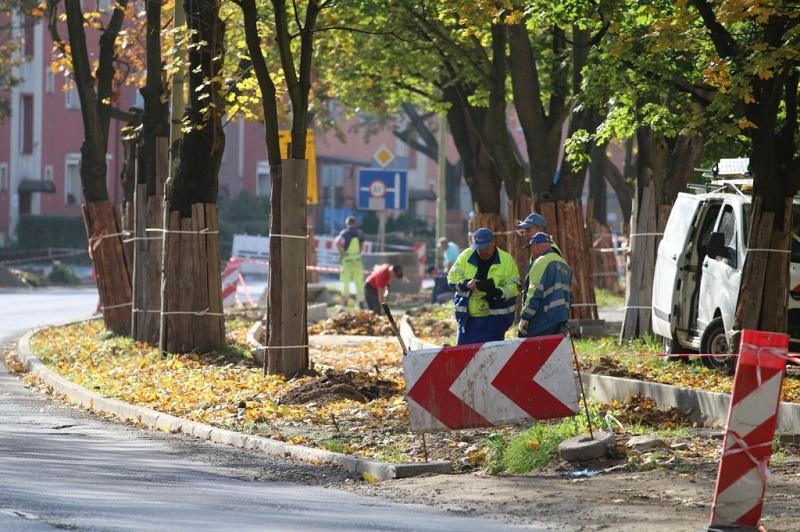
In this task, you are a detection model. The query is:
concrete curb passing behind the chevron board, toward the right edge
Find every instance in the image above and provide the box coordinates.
[399,316,800,439]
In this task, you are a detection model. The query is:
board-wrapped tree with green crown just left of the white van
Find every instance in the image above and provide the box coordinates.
[566,0,707,339]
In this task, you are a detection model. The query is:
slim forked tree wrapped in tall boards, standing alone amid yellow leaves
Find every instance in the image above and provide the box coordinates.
[234,0,324,377]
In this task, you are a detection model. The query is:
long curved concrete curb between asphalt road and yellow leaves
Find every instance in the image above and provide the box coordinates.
[18,329,452,480]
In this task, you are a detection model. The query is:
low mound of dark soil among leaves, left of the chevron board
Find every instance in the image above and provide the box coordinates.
[280,370,402,405]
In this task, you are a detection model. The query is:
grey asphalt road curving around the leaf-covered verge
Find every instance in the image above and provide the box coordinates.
[0,289,524,531]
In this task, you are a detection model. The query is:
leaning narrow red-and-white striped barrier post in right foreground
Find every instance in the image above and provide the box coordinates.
[711,330,789,527]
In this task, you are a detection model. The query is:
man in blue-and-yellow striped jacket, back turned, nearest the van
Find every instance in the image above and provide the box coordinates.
[518,232,572,337]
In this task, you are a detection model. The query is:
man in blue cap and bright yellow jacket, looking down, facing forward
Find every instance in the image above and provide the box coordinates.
[447,227,519,345]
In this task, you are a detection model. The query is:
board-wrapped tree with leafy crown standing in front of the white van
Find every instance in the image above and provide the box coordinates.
[684,0,800,352]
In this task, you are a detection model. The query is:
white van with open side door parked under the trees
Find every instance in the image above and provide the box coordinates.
[652,159,800,366]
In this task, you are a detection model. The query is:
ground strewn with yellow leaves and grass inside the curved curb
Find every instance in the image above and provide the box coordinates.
[23,321,768,472]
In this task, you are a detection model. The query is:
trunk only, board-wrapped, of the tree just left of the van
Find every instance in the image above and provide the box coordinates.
[620,127,703,340]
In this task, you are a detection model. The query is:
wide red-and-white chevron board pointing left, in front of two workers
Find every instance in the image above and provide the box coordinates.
[403,335,578,432]
